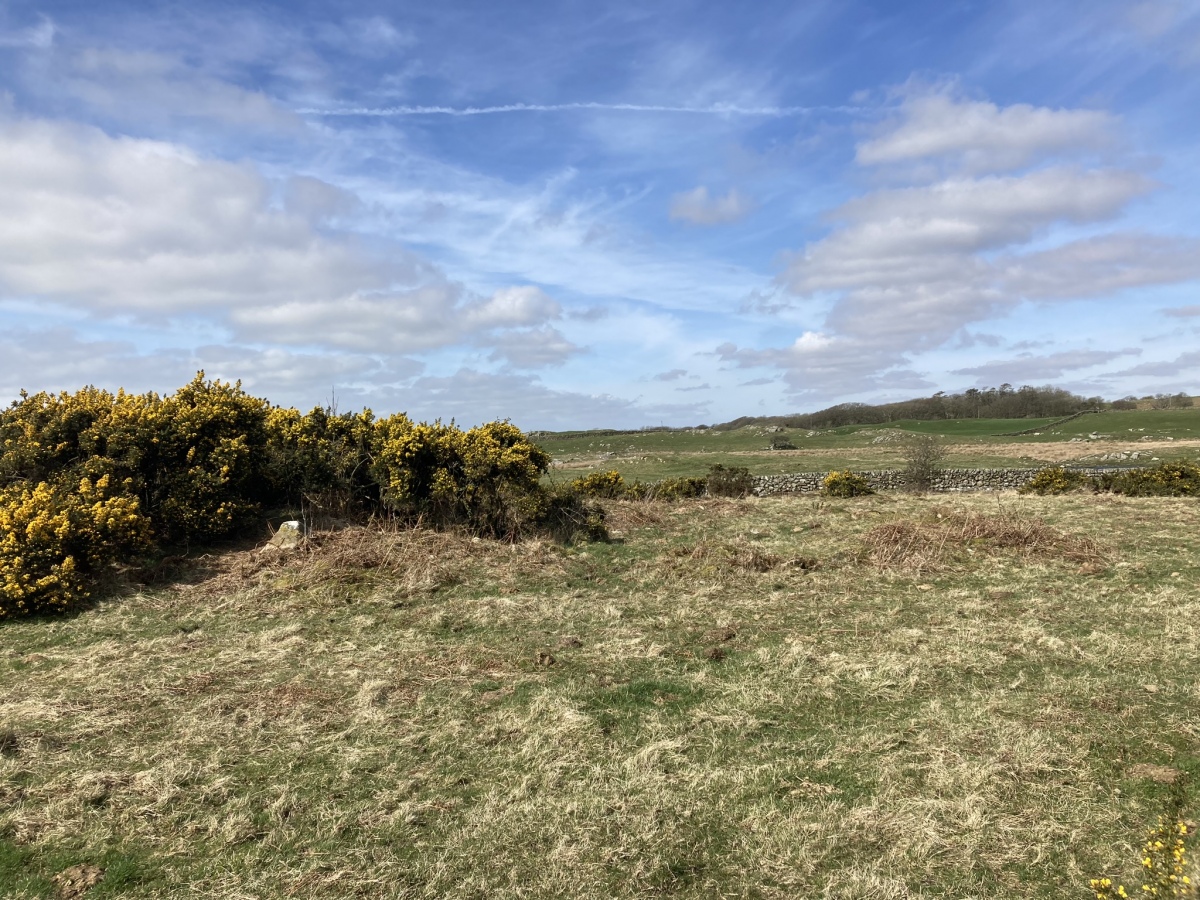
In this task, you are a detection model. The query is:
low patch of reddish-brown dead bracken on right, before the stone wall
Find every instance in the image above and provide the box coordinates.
[864,511,1108,572]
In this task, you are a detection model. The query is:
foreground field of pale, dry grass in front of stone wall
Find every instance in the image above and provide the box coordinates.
[0,494,1200,900]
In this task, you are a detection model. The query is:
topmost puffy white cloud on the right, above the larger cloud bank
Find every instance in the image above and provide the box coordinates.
[857,85,1117,173]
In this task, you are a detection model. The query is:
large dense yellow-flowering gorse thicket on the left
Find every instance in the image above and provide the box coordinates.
[0,372,585,617]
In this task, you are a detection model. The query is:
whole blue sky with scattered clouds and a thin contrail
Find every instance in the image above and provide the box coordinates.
[0,0,1200,430]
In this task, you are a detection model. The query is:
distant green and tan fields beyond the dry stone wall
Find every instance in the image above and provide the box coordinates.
[538,408,1200,481]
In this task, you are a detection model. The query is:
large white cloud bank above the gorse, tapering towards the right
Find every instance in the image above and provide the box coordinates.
[0,112,563,360]
